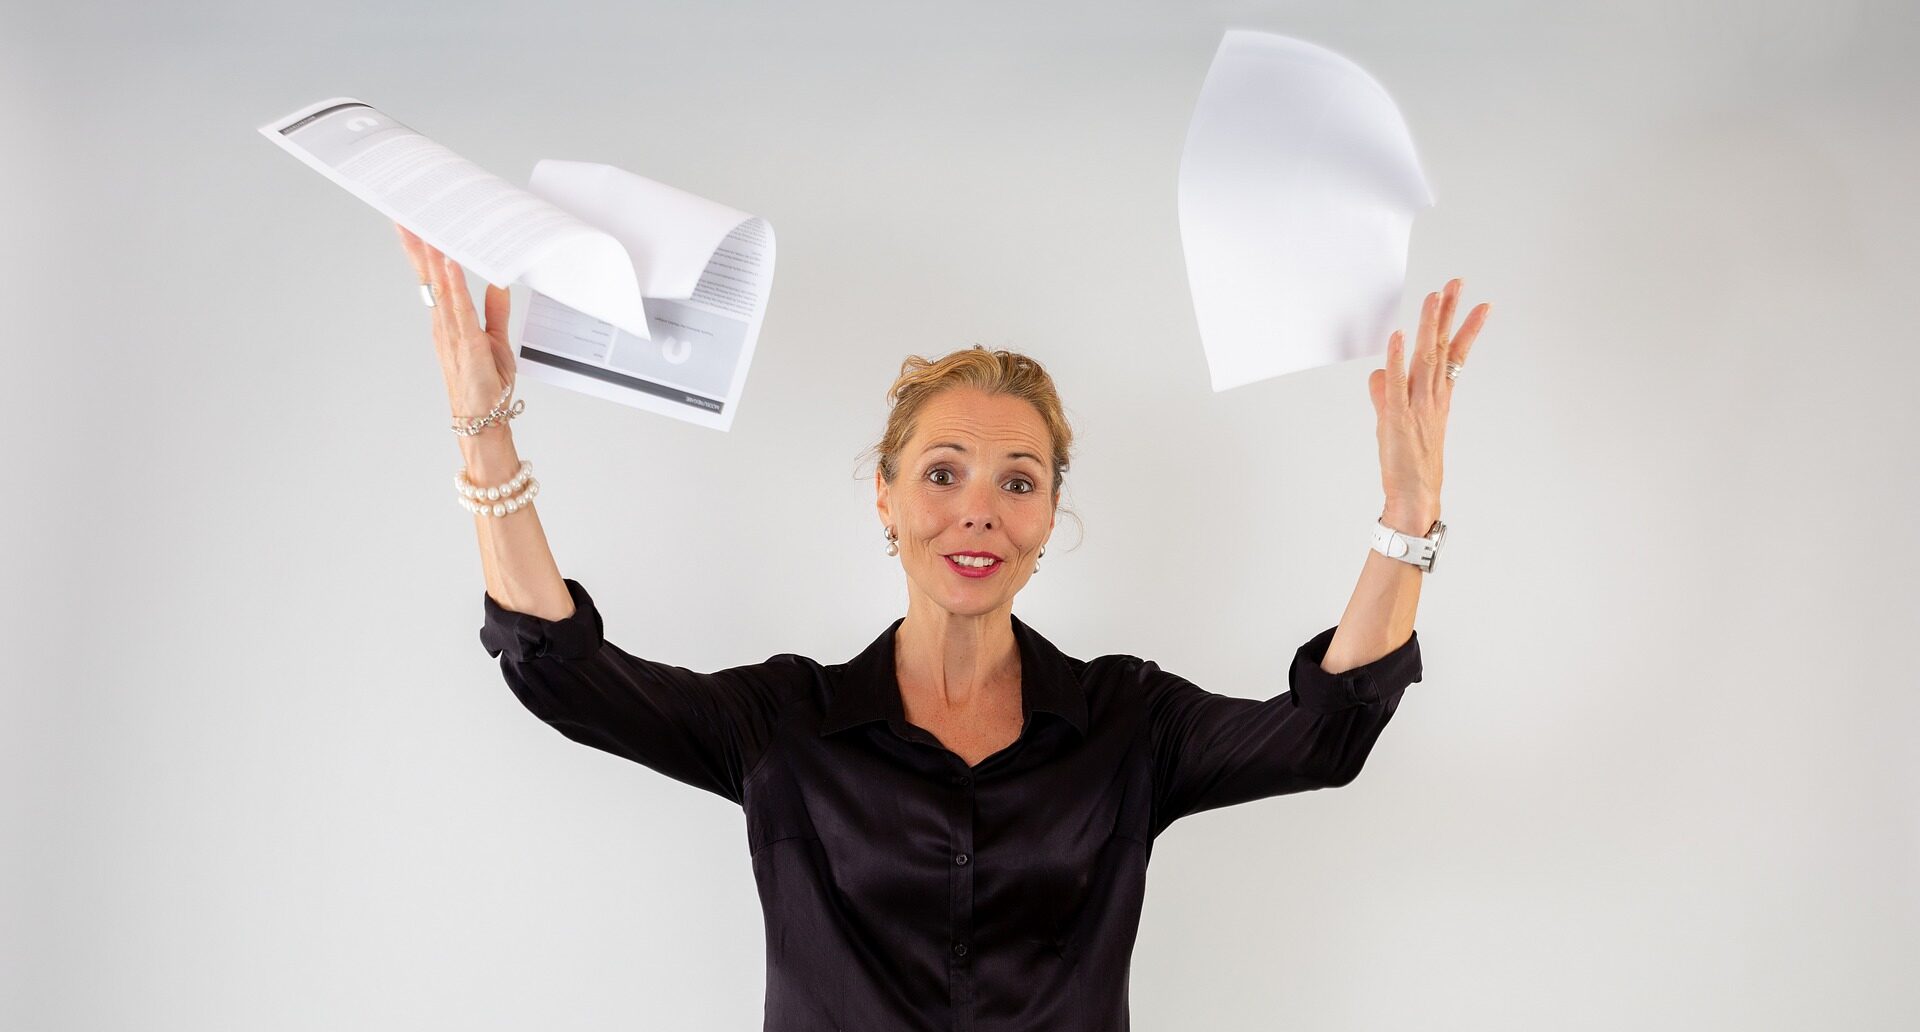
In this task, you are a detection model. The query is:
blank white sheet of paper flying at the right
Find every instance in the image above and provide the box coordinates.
[1179,29,1434,391]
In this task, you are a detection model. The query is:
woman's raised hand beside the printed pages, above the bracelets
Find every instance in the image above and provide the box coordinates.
[394,223,515,418]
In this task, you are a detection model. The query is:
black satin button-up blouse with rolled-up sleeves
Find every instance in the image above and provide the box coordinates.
[480,579,1421,1032]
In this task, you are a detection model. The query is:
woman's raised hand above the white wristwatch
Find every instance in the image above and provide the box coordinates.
[1367,278,1492,535]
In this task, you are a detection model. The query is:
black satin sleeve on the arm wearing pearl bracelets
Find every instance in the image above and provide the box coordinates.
[480,577,804,804]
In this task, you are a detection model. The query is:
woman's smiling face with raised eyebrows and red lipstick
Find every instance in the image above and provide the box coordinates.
[874,387,1054,616]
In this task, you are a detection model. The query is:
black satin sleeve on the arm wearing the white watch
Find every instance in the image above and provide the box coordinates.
[1139,625,1421,836]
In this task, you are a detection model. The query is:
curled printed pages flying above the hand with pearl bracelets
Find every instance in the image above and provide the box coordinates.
[259,98,774,432]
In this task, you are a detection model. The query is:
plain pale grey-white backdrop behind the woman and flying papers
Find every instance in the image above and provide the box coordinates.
[0,0,1920,1032]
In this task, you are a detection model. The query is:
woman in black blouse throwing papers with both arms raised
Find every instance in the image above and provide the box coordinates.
[401,220,1488,1032]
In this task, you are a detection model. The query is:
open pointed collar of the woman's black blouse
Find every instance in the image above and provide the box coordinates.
[820,614,1087,737]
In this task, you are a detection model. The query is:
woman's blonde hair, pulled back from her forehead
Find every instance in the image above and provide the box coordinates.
[870,343,1073,521]
